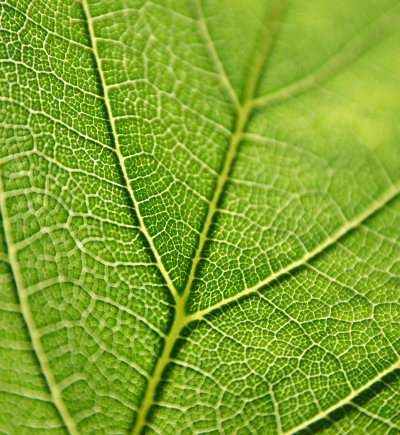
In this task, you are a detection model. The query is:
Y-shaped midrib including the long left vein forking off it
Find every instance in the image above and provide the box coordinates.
[74,0,287,435]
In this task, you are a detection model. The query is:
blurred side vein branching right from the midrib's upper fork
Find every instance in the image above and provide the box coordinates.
[253,5,400,108]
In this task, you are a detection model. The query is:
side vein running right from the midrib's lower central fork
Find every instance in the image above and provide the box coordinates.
[188,182,400,320]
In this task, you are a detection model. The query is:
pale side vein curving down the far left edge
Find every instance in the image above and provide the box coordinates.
[0,177,79,435]
